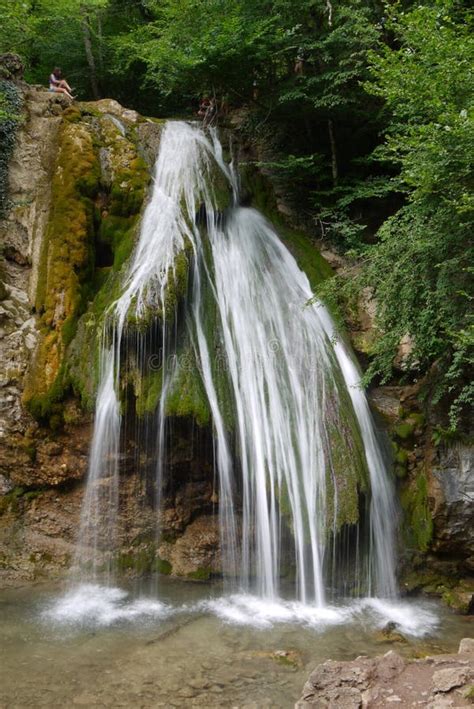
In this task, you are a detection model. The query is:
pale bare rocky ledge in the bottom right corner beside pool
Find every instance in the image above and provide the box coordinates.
[295,638,474,709]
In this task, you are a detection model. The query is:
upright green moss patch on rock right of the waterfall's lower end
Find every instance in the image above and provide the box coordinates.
[400,471,433,551]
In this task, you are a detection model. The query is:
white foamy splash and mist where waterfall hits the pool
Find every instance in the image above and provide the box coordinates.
[40,583,439,638]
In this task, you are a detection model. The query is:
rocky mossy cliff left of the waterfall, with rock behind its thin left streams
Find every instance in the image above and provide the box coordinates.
[0,86,218,584]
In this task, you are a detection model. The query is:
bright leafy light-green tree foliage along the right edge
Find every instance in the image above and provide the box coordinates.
[362,0,474,429]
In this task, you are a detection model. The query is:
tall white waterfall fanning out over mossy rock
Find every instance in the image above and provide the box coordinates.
[75,122,396,606]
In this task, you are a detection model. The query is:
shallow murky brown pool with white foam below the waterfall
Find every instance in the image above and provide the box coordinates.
[0,579,472,708]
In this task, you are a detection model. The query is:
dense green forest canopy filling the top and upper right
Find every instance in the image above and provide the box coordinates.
[0,0,474,432]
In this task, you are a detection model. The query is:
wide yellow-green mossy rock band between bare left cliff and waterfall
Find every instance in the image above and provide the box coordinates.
[23,104,156,420]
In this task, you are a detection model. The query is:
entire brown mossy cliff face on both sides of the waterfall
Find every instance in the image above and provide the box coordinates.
[0,77,474,610]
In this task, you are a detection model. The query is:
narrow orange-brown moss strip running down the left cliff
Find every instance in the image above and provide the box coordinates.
[23,121,100,420]
